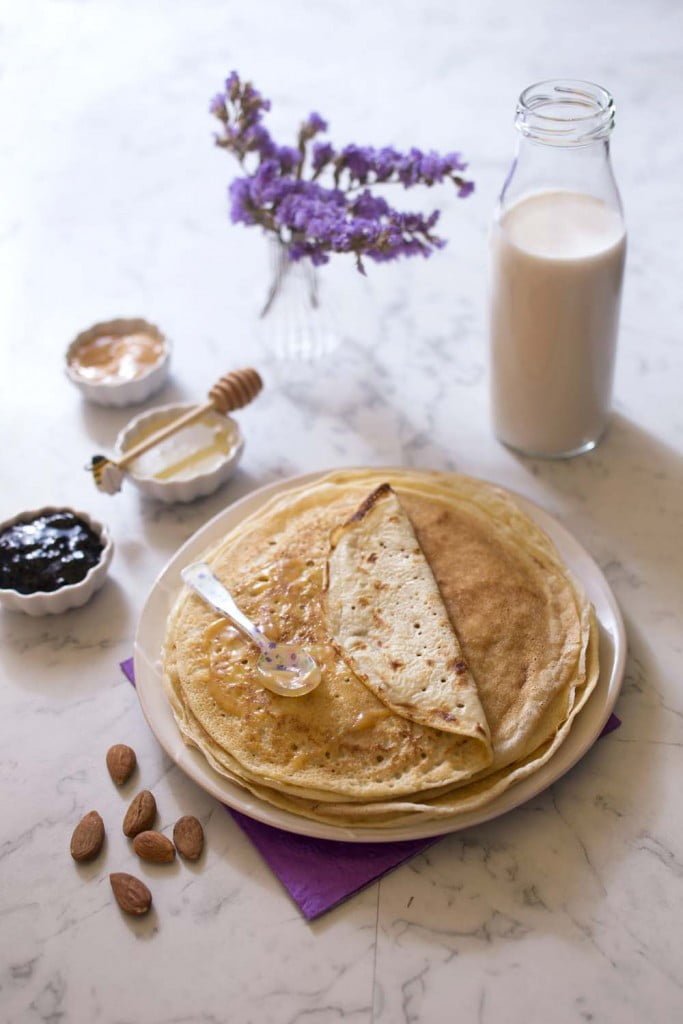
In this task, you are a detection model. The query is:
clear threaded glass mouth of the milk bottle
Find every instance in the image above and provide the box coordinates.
[515,79,614,146]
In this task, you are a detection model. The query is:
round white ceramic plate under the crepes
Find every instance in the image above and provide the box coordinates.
[134,473,626,843]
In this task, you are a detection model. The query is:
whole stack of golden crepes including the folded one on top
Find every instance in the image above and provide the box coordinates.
[164,470,598,828]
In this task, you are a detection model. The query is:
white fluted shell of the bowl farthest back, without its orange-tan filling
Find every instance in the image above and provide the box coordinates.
[66,317,171,407]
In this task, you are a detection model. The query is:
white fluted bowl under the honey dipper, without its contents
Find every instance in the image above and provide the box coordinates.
[116,403,245,504]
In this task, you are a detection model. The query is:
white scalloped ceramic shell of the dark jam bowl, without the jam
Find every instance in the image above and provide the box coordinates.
[0,505,114,615]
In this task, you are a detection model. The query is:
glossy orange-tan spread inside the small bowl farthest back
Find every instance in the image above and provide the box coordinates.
[69,329,165,384]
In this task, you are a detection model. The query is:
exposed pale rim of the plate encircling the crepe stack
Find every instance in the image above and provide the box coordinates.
[133,466,627,843]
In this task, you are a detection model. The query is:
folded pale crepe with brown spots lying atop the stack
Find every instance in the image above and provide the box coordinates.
[327,483,493,745]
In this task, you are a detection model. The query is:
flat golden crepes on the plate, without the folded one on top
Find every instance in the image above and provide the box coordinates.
[164,470,597,827]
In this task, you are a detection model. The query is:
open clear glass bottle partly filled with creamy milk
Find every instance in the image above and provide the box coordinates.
[490,79,626,458]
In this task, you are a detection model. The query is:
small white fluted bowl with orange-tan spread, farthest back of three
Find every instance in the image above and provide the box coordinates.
[66,316,171,407]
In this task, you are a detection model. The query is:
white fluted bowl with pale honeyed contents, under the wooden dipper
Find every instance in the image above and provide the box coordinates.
[116,403,245,503]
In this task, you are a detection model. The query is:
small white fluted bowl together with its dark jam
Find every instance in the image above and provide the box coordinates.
[0,505,114,615]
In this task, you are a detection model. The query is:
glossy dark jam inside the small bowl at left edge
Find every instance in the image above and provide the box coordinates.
[0,511,104,594]
